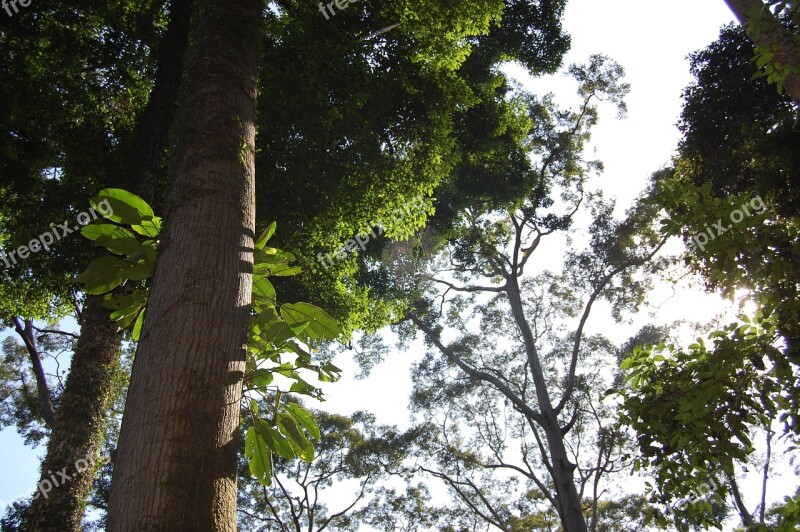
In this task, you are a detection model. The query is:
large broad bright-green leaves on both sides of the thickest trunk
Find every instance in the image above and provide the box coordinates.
[77,189,342,485]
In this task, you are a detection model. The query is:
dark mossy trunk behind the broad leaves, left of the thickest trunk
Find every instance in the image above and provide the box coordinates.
[23,0,191,532]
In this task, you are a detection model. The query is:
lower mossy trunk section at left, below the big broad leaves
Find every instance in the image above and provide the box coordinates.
[24,297,120,532]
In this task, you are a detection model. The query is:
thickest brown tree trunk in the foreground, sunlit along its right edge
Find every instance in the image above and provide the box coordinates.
[108,0,261,531]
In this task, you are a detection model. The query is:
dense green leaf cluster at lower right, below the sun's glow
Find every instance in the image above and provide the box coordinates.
[620,313,797,527]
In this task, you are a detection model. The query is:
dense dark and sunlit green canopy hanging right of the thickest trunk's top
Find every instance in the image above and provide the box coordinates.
[256,0,569,331]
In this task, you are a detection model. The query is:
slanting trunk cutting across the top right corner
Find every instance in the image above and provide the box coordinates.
[725,0,800,106]
